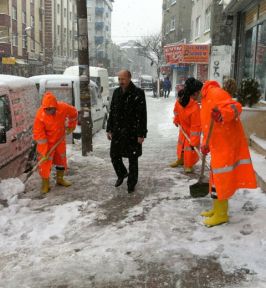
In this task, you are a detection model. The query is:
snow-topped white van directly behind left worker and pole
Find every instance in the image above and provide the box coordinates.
[30,74,105,139]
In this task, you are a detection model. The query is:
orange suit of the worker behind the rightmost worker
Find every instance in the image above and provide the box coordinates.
[174,98,201,167]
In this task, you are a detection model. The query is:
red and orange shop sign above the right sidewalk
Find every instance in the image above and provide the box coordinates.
[164,44,210,64]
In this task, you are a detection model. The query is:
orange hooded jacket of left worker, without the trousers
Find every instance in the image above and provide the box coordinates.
[33,92,78,156]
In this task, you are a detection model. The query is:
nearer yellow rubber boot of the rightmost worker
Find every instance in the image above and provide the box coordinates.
[203,200,229,227]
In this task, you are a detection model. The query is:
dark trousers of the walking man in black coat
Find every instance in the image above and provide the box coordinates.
[111,155,139,187]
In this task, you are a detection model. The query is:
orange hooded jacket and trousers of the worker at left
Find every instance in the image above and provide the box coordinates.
[33,92,78,179]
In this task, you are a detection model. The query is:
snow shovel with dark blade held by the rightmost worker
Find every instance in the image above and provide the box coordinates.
[189,119,214,198]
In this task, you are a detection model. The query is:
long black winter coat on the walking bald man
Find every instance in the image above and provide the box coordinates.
[106,82,147,158]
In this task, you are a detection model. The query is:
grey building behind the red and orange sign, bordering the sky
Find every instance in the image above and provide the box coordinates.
[161,0,192,87]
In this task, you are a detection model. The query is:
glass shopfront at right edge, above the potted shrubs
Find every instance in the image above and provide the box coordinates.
[224,0,266,99]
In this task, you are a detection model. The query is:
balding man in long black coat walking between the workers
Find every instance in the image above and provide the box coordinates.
[106,70,147,193]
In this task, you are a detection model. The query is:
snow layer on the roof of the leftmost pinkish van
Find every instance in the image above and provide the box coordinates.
[0,74,35,90]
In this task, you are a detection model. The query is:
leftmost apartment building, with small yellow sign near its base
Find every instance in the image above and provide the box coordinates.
[0,0,44,76]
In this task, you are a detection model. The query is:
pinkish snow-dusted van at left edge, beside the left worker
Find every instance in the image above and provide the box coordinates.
[0,75,40,179]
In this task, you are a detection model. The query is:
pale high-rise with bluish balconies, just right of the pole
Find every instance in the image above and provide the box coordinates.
[87,0,114,68]
